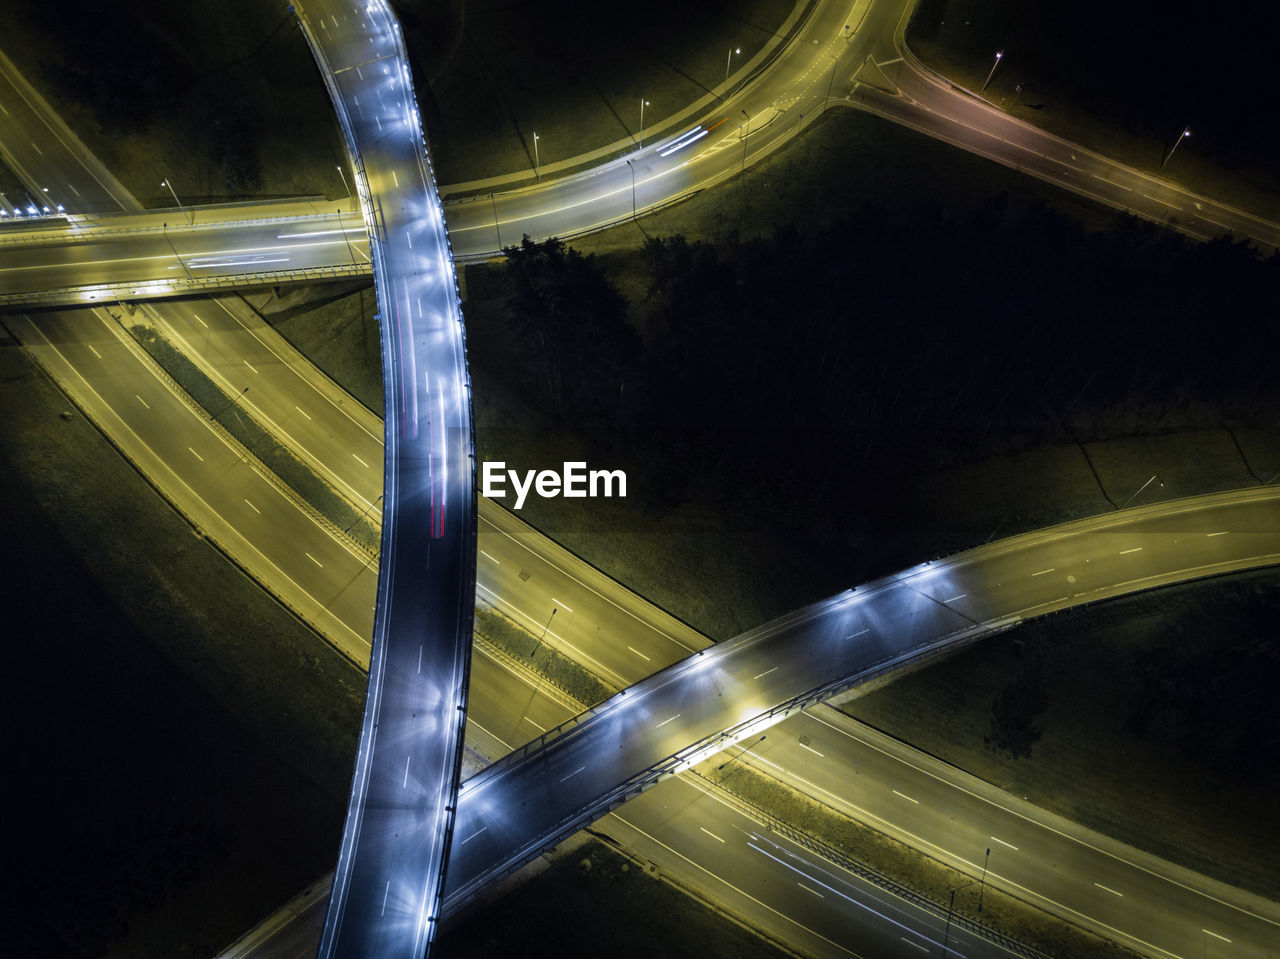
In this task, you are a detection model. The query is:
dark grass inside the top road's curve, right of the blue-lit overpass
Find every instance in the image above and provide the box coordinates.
[399,0,792,183]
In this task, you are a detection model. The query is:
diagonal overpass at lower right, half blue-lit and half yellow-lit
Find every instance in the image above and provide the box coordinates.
[448,489,1280,956]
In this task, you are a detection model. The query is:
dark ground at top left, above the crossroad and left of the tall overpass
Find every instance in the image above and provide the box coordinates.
[0,0,342,199]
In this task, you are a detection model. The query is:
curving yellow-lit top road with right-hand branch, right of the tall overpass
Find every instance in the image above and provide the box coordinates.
[0,0,1280,303]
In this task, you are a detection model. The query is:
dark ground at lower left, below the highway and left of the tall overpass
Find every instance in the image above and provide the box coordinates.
[0,335,364,959]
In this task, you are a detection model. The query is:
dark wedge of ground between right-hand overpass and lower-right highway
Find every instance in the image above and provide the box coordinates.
[840,570,1280,898]
